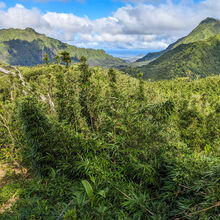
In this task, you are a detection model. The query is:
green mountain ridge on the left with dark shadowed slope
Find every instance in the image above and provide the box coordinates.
[0,28,125,67]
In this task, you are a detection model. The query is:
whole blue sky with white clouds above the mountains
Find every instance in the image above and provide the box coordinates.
[0,0,220,57]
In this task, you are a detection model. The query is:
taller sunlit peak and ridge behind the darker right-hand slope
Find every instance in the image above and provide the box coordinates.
[136,18,220,62]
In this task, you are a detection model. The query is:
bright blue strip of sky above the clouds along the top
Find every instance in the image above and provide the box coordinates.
[1,0,204,19]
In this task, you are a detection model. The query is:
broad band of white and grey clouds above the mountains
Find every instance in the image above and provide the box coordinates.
[0,0,220,49]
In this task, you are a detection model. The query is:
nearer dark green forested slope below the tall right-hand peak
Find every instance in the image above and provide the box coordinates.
[136,35,220,80]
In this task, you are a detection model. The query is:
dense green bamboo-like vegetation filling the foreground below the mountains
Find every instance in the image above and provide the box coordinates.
[0,57,220,220]
